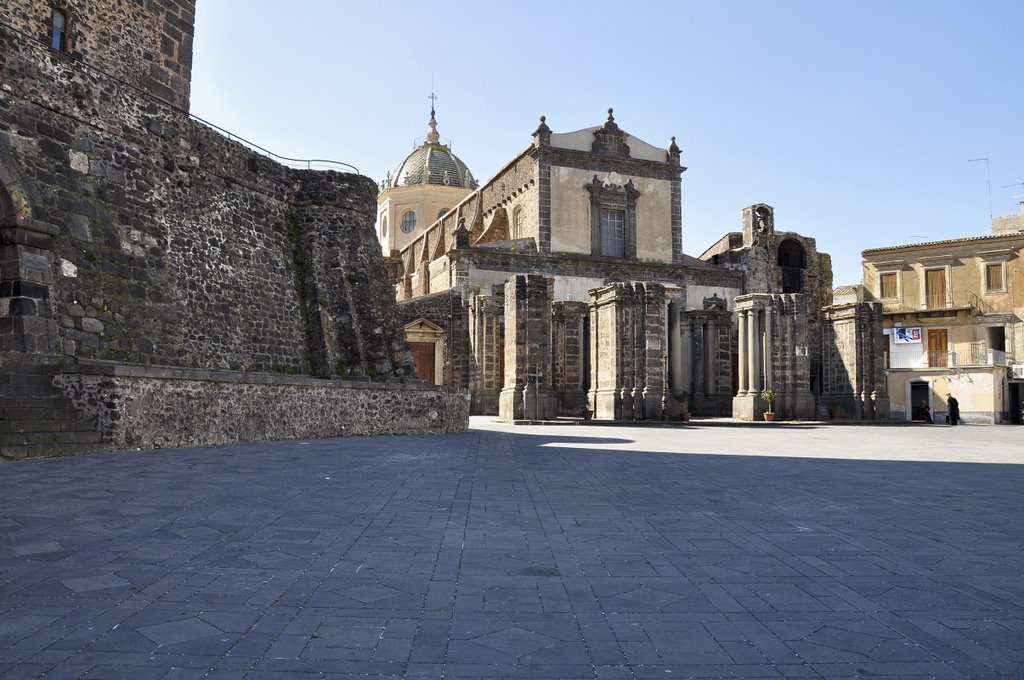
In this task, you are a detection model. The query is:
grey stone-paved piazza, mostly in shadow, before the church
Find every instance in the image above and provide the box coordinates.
[0,418,1024,680]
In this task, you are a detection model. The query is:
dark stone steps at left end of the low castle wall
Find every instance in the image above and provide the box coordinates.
[0,355,110,460]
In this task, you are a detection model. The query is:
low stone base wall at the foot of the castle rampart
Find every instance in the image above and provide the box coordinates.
[48,364,469,451]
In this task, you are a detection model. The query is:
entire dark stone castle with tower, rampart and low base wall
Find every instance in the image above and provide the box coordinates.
[0,6,468,457]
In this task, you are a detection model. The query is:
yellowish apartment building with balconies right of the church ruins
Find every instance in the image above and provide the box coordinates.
[861,203,1024,424]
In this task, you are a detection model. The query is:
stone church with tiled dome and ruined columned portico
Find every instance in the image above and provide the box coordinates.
[378,110,888,420]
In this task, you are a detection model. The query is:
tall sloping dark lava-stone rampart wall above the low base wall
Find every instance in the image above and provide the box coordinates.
[0,21,412,375]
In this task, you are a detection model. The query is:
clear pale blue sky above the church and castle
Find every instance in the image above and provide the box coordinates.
[191,0,1024,285]
